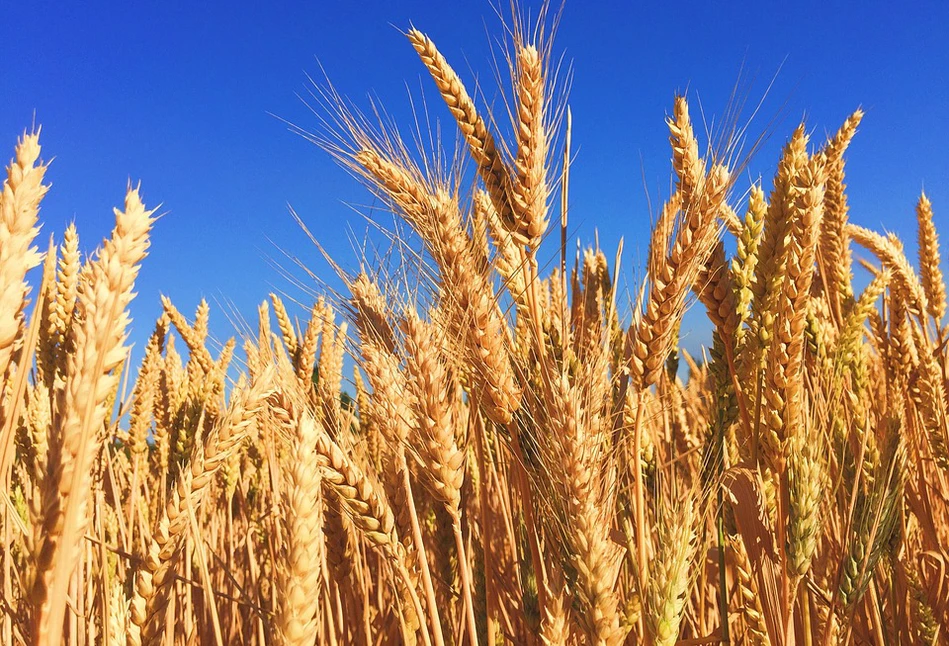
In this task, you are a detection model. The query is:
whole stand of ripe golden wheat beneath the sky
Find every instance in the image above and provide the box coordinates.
[0,13,949,646]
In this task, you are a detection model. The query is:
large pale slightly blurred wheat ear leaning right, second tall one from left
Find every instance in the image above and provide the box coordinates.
[32,189,154,643]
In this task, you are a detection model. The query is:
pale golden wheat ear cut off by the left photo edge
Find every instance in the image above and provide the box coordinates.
[0,131,49,380]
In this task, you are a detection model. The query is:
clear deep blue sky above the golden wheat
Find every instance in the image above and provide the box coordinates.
[0,0,949,360]
